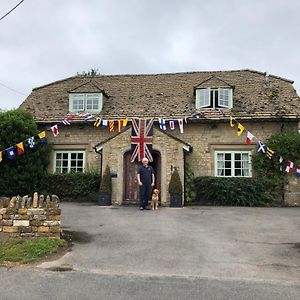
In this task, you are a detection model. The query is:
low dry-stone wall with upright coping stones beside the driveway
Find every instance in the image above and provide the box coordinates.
[0,193,61,239]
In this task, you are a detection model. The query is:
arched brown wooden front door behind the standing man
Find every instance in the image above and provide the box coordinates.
[123,151,161,205]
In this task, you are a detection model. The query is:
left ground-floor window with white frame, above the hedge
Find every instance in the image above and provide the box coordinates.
[54,151,85,173]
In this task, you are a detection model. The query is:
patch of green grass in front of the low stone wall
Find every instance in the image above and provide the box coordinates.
[0,238,67,264]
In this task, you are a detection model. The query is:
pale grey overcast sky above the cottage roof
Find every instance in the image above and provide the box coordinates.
[0,0,300,108]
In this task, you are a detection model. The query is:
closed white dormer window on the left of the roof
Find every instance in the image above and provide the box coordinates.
[69,93,102,112]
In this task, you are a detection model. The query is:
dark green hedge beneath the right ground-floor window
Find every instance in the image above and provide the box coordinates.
[194,177,273,206]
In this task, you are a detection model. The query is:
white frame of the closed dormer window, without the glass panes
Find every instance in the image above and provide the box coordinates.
[69,93,103,112]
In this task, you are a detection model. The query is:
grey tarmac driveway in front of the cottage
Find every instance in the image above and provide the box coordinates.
[38,203,300,284]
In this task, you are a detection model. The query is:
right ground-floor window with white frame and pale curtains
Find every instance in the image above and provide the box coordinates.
[215,151,252,177]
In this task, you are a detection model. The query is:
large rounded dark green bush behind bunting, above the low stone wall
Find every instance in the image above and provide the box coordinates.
[0,109,50,196]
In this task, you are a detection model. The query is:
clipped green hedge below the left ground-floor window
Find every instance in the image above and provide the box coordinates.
[41,172,100,201]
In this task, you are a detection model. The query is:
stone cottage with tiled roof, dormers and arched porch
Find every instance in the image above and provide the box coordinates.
[21,70,300,206]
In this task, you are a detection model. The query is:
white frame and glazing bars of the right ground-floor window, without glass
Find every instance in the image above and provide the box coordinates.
[214,150,252,177]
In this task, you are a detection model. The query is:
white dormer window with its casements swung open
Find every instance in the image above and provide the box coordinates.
[196,88,232,109]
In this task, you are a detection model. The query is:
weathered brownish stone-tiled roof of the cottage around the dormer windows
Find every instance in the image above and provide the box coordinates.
[21,70,300,123]
